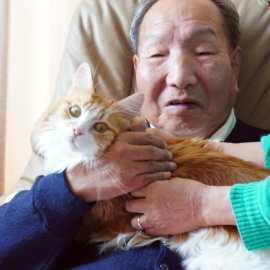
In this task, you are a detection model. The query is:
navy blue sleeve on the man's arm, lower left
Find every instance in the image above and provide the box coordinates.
[0,173,93,269]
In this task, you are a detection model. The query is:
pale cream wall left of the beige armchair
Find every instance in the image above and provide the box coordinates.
[0,0,79,194]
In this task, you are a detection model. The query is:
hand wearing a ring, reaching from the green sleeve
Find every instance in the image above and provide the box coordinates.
[126,178,235,235]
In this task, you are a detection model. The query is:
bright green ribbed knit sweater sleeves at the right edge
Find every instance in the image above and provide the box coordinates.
[230,134,270,250]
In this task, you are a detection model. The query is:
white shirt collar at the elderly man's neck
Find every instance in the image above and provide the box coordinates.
[150,108,236,142]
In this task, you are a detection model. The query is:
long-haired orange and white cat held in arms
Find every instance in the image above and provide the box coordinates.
[36,63,270,270]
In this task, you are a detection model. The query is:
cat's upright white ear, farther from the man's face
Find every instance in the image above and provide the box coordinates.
[72,62,94,91]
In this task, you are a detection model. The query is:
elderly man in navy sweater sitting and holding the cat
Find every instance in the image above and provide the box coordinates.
[0,0,268,269]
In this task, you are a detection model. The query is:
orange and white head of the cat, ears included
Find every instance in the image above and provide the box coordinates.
[35,63,144,172]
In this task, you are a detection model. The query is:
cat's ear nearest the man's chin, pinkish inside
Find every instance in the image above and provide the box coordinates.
[117,93,144,120]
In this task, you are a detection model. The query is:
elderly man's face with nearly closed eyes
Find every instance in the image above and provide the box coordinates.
[133,0,241,137]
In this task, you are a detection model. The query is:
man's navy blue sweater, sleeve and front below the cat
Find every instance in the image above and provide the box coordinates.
[0,173,182,270]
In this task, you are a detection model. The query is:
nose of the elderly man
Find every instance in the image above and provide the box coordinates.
[166,53,197,89]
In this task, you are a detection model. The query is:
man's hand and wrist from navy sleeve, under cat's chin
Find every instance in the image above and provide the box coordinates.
[66,132,176,202]
